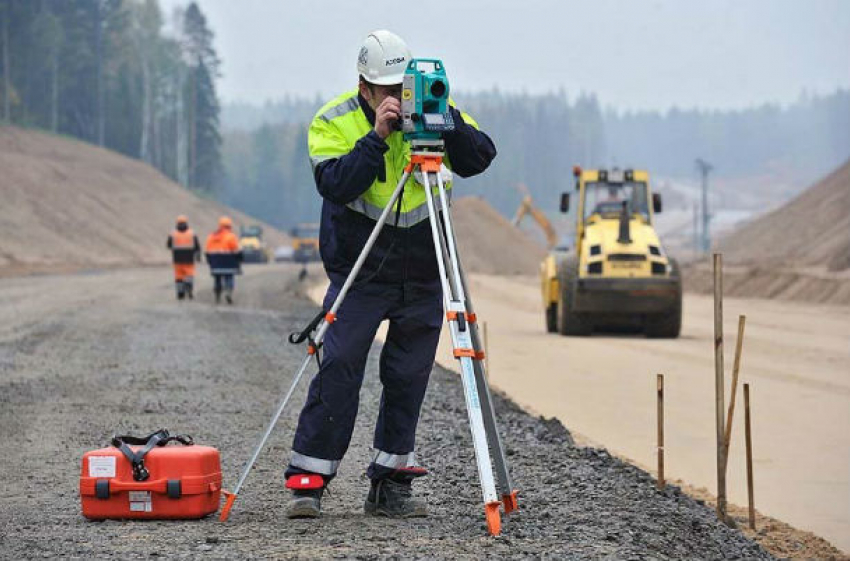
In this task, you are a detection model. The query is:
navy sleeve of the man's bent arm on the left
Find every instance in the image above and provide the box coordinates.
[313,131,389,205]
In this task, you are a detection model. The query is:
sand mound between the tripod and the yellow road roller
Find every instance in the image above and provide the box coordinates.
[452,197,546,275]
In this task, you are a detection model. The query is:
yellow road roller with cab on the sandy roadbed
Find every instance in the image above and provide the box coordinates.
[540,166,682,338]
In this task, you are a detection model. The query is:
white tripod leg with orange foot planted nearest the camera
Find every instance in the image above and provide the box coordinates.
[422,167,501,535]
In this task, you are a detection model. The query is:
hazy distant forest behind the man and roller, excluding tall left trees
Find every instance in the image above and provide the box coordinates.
[221,90,850,227]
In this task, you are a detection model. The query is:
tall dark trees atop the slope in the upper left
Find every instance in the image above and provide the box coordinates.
[0,0,223,192]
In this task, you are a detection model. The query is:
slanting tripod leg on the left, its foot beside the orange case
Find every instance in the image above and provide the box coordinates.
[219,171,410,522]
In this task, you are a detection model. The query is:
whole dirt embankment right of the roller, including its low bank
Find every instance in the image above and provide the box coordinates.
[685,161,850,304]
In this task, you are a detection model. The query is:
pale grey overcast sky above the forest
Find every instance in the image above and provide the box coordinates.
[161,0,850,109]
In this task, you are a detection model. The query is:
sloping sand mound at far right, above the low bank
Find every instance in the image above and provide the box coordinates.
[720,161,850,271]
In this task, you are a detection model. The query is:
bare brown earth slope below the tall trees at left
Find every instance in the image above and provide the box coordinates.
[0,126,285,275]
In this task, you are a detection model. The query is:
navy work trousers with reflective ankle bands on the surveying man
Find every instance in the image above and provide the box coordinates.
[286,282,443,481]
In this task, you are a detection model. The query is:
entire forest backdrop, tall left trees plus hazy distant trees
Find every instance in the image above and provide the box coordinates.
[0,0,850,228]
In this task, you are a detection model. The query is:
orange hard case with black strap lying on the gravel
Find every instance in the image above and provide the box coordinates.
[80,430,221,520]
